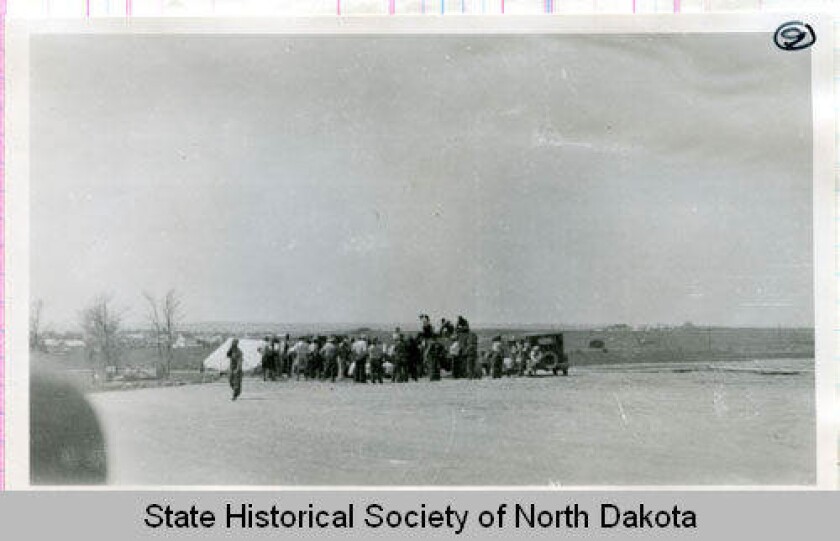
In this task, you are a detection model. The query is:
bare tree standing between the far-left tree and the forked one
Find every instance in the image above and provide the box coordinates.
[80,295,122,373]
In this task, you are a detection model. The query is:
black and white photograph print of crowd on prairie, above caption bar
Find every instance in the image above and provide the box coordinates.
[23,21,836,487]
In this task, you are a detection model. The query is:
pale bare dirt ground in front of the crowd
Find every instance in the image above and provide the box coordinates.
[89,360,815,486]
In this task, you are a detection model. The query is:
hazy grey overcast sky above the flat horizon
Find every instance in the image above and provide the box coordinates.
[31,35,813,327]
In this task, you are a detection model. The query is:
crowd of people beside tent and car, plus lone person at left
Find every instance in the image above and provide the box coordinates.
[227,314,560,400]
